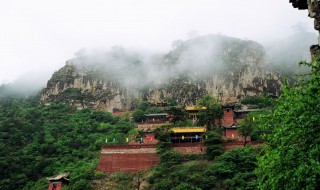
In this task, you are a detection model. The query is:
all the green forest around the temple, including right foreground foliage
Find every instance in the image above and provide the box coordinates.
[0,59,320,190]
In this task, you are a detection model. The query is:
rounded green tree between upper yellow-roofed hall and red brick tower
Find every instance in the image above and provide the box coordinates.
[197,95,223,130]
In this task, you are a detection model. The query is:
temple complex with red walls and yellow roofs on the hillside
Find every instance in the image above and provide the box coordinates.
[97,104,260,174]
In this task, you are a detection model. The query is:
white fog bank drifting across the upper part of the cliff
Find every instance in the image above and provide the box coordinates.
[67,31,317,88]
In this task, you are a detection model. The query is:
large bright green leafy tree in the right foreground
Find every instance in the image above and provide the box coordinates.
[257,58,320,189]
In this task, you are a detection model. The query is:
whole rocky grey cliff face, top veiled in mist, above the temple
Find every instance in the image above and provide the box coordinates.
[41,35,281,111]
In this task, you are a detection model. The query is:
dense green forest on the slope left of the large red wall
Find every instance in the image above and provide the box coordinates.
[0,99,133,189]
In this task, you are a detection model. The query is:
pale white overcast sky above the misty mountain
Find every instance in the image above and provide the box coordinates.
[0,0,313,85]
